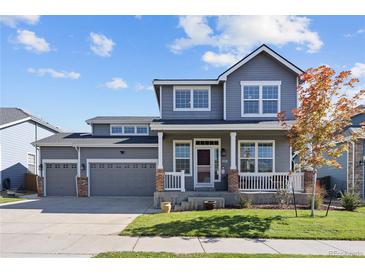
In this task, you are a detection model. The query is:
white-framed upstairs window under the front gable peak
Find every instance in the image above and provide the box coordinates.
[241,81,281,117]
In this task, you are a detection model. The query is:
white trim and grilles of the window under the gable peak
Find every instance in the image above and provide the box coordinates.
[241,81,281,117]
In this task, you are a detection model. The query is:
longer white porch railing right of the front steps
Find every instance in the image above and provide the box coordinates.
[239,172,304,192]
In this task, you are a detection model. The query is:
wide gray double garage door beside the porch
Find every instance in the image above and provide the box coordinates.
[89,162,156,196]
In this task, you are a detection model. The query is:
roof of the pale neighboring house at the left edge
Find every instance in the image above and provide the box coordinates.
[0,107,62,132]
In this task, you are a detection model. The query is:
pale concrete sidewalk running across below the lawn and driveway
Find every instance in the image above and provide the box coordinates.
[1,235,365,257]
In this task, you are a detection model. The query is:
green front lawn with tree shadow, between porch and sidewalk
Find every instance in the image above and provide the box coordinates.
[120,207,365,240]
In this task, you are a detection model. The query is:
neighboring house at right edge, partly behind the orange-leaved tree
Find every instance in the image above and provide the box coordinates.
[318,106,365,198]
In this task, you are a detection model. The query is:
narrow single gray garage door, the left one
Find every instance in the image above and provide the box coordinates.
[46,163,77,196]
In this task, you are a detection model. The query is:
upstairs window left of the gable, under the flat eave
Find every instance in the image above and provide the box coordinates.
[174,86,210,111]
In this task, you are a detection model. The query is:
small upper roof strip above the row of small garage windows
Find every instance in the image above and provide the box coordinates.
[86,116,158,125]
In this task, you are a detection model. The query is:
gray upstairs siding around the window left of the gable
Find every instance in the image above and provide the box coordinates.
[162,85,223,119]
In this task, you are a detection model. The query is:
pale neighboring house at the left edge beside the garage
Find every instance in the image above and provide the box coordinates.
[0,107,60,189]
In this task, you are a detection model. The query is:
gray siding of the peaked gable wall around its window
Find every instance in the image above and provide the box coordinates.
[226,53,297,120]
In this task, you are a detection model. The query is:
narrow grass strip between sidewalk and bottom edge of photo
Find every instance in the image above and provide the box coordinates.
[95,251,365,258]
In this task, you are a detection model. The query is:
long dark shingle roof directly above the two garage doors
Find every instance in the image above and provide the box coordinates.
[33,133,158,147]
